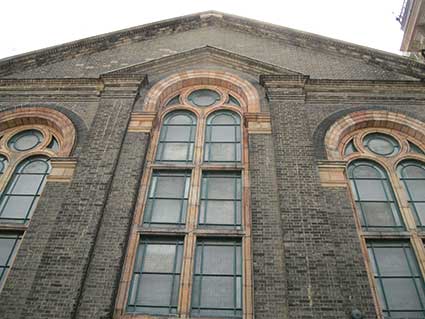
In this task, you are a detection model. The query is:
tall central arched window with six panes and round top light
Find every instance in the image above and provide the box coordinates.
[118,85,252,318]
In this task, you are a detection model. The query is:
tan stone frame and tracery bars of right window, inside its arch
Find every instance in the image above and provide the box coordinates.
[338,127,425,319]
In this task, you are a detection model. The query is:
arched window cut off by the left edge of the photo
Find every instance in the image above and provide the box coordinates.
[0,125,61,289]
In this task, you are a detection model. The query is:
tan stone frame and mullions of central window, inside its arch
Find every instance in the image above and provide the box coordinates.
[115,85,253,319]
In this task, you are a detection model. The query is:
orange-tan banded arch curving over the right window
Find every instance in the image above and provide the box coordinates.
[325,111,425,160]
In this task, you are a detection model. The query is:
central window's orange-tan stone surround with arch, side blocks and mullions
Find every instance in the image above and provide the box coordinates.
[114,71,256,319]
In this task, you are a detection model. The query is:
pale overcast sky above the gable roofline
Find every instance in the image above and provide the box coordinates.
[0,0,403,58]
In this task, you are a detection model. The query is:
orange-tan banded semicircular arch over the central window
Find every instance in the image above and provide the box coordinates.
[145,70,260,113]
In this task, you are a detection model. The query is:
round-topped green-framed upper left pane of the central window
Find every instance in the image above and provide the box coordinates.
[155,111,196,163]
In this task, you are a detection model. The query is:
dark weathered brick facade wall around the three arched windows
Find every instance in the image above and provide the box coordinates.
[0,12,425,319]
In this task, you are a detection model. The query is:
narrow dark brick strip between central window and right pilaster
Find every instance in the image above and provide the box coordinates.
[249,134,288,319]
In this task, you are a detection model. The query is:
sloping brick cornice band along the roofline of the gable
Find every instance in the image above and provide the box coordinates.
[0,11,425,79]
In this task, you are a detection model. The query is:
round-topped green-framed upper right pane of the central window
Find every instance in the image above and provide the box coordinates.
[204,110,242,163]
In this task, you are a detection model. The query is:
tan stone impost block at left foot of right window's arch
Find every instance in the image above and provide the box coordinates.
[318,161,347,187]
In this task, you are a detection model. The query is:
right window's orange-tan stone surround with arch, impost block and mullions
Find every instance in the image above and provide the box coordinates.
[319,111,425,318]
